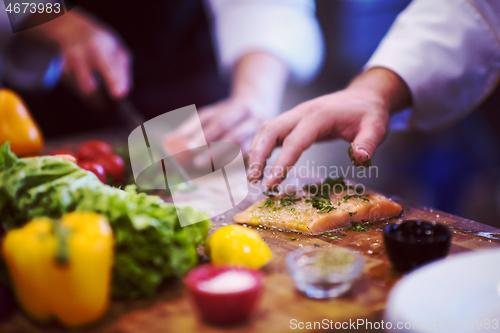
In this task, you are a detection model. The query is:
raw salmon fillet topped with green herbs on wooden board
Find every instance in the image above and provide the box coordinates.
[234,182,402,235]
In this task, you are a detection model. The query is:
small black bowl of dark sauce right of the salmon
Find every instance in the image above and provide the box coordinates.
[383,220,452,273]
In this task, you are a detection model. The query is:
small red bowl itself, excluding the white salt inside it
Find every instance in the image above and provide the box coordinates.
[184,264,263,325]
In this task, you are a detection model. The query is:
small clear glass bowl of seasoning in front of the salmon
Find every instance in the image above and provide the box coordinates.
[286,247,364,298]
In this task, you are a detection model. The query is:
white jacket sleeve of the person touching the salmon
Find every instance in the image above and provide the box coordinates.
[365,0,500,130]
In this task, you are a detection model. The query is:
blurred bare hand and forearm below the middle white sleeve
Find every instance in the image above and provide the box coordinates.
[167,52,288,168]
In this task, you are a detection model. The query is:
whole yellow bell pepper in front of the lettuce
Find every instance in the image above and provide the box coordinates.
[2,212,114,327]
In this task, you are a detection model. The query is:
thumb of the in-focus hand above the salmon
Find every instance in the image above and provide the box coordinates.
[348,119,388,167]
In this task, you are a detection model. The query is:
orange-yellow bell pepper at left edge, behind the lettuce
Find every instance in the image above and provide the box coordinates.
[0,89,43,156]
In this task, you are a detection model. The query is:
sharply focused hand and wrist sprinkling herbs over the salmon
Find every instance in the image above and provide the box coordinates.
[248,68,411,187]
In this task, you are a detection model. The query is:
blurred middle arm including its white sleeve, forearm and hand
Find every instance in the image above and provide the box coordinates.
[170,0,323,167]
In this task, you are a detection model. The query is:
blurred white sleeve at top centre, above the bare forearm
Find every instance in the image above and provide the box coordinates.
[208,0,324,82]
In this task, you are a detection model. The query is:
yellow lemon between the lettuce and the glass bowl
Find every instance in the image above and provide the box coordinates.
[205,225,272,268]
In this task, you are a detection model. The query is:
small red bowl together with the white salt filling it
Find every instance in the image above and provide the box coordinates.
[184,264,263,326]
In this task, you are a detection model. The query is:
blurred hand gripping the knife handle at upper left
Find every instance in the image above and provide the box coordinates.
[34,10,131,101]
